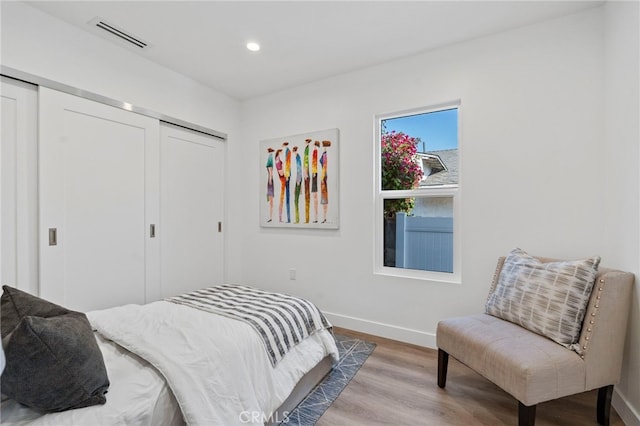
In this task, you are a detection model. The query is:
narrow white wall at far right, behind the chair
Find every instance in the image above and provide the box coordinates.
[601,2,640,426]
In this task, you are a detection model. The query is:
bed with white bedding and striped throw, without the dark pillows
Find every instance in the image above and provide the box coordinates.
[1,286,338,426]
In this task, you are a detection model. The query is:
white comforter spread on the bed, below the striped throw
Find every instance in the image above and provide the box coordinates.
[87,301,338,426]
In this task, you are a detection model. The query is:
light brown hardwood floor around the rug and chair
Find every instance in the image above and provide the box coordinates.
[317,327,624,426]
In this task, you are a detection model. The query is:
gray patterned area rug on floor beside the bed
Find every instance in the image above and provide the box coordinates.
[280,334,376,426]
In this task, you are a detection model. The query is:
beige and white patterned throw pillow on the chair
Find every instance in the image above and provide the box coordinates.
[486,248,600,353]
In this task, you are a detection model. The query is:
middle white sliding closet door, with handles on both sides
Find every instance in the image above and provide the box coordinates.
[39,87,160,311]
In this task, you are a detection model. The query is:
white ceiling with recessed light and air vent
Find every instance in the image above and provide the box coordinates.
[27,1,602,100]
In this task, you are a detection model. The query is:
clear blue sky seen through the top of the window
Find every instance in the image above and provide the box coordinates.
[383,108,458,152]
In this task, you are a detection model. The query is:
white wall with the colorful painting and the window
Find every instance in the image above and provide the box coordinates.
[235,9,606,347]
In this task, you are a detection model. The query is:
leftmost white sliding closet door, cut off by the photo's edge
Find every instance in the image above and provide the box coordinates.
[0,77,38,295]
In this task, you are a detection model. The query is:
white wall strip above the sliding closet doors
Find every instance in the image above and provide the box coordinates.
[0,1,238,133]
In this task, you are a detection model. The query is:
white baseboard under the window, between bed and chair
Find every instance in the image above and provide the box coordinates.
[324,312,436,349]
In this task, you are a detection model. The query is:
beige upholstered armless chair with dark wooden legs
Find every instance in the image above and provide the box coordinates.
[436,252,634,426]
